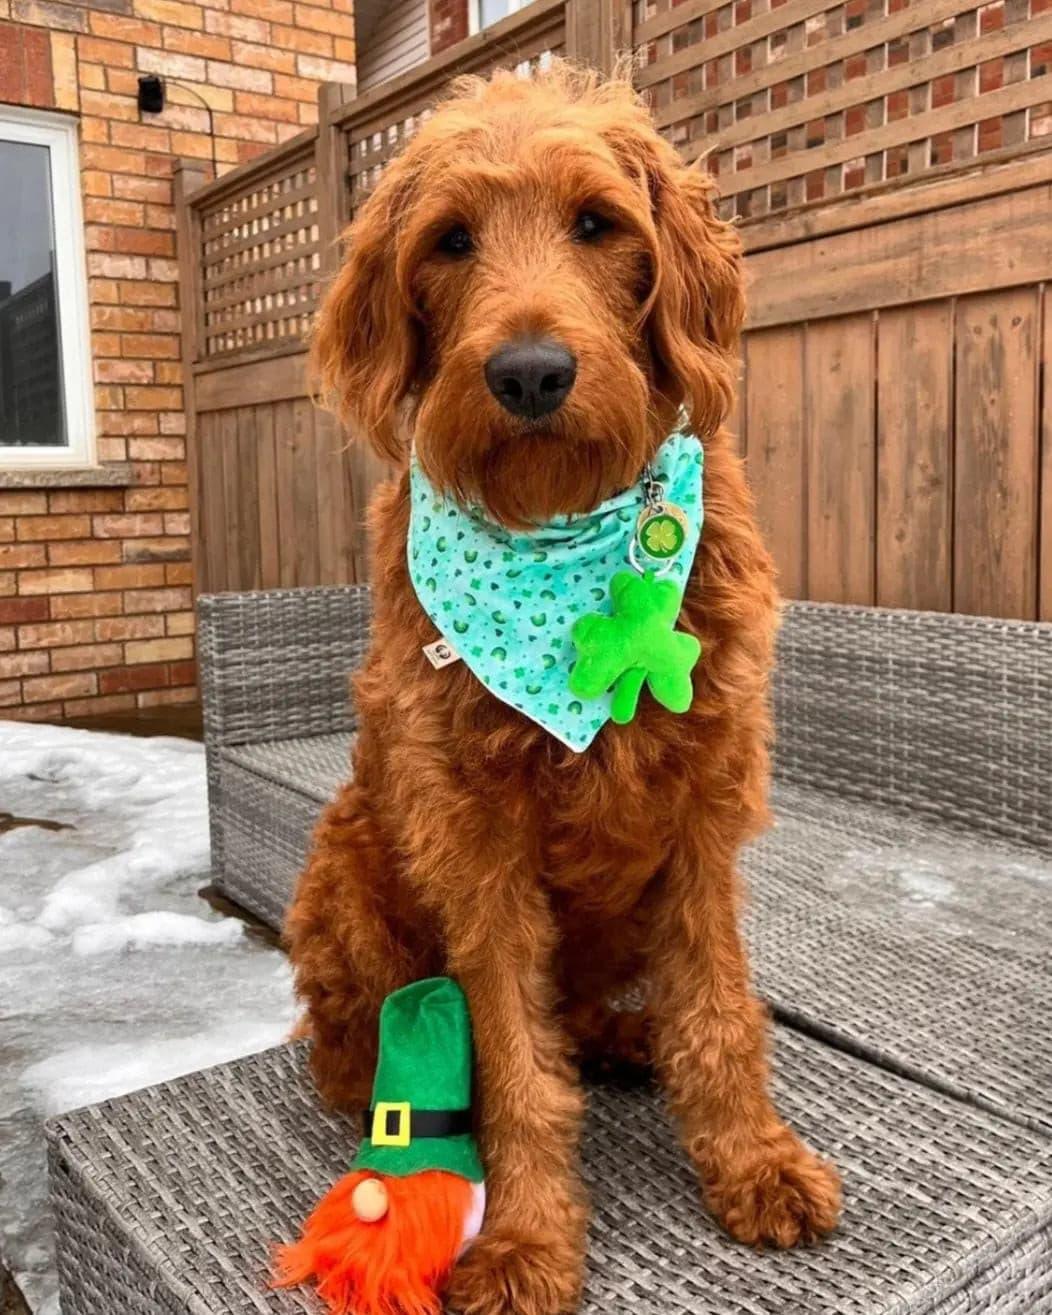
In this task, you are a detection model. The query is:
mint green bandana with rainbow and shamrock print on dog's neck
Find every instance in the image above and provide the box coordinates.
[408,434,704,752]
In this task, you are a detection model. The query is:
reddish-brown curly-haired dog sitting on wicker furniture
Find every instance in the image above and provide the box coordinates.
[288,64,839,1315]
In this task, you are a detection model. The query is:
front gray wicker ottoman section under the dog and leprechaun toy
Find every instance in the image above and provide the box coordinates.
[50,1030,1052,1315]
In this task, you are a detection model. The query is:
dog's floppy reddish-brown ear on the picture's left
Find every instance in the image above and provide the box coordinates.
[310,160,418,464]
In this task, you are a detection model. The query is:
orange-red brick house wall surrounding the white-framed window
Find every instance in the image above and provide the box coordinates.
[0,0,355,721]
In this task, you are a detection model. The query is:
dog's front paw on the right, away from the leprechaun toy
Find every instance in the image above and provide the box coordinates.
[705,1128,840,1247]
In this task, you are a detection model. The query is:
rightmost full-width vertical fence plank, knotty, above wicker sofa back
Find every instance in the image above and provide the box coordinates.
[953,288,1039,618]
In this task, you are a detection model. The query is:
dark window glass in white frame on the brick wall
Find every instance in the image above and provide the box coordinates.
[0,137,67,447]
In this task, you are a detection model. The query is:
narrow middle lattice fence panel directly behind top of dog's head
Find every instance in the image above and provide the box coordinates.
[347,24,563,213]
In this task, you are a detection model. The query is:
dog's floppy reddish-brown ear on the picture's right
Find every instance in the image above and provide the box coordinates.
[621,125,746,434]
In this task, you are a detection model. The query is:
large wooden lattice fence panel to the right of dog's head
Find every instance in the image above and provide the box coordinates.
[635,0,1052,218]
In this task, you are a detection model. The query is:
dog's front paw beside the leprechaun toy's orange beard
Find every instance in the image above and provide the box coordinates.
[446,1230,584,1315]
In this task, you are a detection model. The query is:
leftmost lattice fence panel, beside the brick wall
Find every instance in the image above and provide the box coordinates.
[201,143,321,358]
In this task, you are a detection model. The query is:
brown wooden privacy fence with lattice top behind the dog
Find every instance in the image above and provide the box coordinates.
[180,0,1052,618]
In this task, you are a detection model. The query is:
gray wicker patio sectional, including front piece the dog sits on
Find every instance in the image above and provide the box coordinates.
[50,589,1052,1315]
